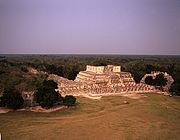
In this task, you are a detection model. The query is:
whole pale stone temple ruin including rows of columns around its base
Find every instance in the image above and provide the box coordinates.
[49,65,157,96]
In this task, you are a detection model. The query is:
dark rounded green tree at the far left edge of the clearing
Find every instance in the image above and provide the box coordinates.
[0,87,24,109]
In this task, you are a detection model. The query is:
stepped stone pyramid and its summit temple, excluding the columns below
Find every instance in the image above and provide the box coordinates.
[75,65,135,86]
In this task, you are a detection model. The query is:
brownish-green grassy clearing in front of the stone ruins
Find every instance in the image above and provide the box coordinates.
[0,94,180,140]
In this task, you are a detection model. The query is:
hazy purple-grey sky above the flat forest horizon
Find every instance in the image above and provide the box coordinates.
[0,0,180,55]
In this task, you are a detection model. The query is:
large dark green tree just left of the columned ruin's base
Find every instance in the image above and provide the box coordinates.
[34,80,63,108]
